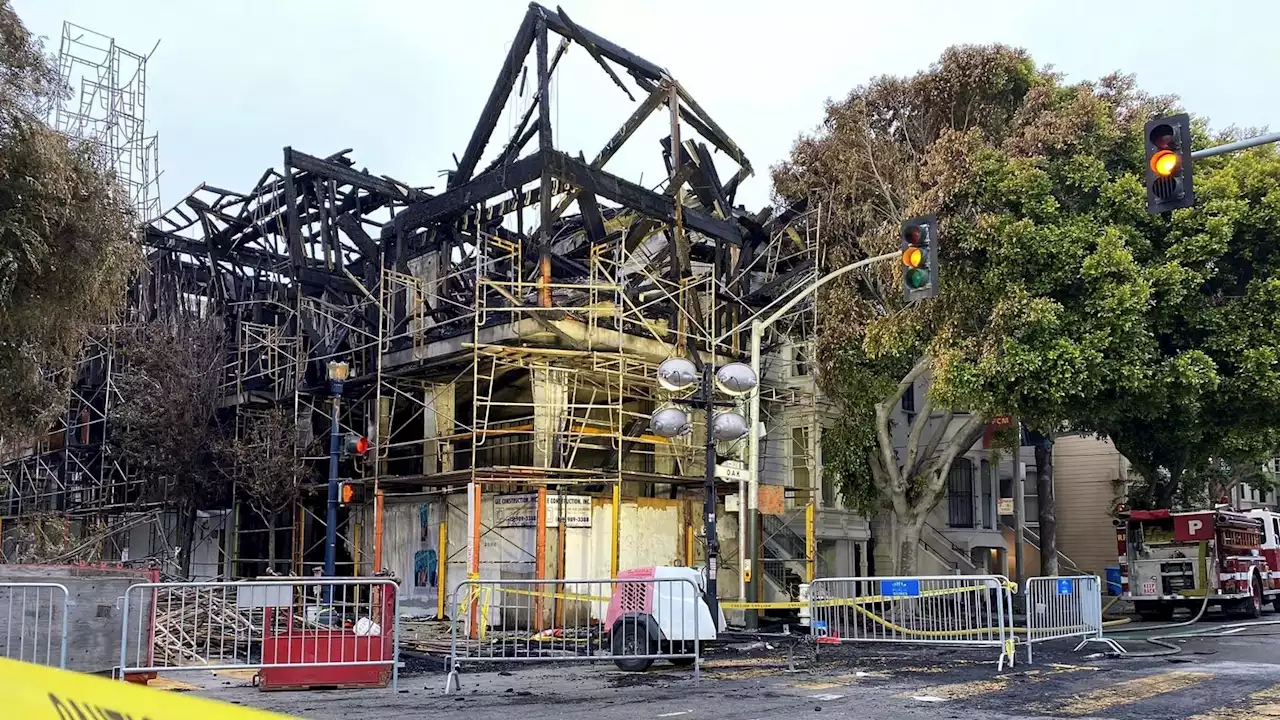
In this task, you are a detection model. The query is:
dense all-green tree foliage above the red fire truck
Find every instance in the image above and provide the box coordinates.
[1082,132,1280,507]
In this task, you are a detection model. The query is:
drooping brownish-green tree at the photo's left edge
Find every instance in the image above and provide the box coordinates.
[0,0,141,436]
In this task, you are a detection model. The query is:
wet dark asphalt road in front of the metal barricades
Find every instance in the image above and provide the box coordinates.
[183,615,1280,720]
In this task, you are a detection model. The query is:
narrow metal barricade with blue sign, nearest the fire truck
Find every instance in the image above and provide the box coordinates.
[1023,575,1123,662]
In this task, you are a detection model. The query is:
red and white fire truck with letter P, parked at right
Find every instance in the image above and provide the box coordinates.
[1115,507,1280,620]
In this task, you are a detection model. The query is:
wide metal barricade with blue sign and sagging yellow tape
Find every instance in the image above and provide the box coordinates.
[809,575,1014,670]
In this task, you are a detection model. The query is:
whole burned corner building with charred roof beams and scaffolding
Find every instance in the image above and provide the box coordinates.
[0,4,867,607]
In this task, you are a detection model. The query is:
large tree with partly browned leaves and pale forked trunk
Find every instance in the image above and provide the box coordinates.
[773,46,1280,573]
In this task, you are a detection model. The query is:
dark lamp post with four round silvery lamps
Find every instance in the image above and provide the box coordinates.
[649,357,756,623]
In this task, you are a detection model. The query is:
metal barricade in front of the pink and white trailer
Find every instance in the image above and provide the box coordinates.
[444,570,717,693]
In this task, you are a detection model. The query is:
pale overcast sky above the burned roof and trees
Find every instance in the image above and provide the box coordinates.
[13,0,1280,213]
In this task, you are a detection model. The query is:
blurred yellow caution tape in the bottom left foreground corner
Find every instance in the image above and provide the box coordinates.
[0,659,288,720]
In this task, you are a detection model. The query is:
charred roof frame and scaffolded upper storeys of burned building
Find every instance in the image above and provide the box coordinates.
[3,4,819,584]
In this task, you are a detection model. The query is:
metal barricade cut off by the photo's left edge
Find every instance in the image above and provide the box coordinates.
[0,583,68,667]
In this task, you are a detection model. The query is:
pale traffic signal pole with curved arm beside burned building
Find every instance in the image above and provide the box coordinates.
[739,250,902,629]
